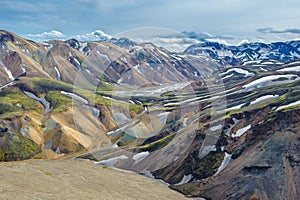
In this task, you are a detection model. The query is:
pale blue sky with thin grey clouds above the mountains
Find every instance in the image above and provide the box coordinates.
[0,0,300,43]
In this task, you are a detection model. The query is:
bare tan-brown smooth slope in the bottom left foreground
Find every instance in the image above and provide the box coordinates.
[0,160,186,200]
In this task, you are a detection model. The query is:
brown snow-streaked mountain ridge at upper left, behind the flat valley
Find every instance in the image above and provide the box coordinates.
[0,31,219,85]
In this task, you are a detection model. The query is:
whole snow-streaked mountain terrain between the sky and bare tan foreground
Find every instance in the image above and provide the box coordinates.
[0,31,300,199]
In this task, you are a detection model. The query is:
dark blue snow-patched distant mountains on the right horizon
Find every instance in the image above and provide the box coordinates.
[184,41,300,66]
